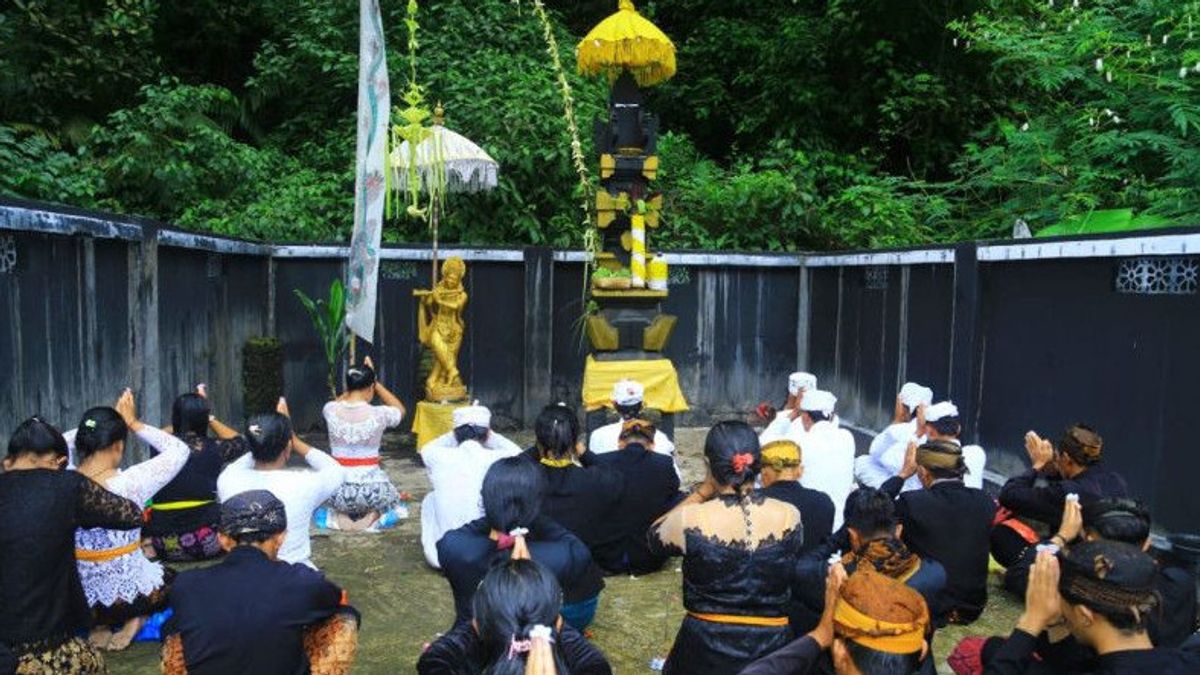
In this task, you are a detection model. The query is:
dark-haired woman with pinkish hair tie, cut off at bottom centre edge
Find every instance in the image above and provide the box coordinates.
[416,560,612,675]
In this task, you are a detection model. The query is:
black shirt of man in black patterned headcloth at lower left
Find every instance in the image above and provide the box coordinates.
[167,546,342,675]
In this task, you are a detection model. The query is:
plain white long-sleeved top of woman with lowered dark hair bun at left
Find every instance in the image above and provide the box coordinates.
[217,448,346,569]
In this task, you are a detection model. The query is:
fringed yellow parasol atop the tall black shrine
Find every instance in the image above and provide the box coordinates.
[575,0,674,86]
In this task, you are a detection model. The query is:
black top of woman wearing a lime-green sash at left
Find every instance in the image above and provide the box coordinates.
[144,434,250,537]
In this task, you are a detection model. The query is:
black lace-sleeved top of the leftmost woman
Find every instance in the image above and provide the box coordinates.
[0,468,142,646]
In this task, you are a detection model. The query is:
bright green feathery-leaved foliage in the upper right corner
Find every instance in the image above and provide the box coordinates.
[954,0,1200,232]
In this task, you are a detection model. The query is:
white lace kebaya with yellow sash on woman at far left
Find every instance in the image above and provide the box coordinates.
[70,424,191,607]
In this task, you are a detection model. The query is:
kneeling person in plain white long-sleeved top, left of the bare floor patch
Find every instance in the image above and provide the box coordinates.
[217,399,346,569]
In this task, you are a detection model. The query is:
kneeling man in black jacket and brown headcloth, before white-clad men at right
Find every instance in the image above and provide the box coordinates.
[882,441,996,628]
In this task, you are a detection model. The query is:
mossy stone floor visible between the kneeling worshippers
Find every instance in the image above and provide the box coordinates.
[107,429,1020,675]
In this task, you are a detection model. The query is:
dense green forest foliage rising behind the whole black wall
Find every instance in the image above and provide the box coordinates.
[0,0,1200,251]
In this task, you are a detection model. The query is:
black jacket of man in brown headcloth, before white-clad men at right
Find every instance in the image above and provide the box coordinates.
[881,476,993,622]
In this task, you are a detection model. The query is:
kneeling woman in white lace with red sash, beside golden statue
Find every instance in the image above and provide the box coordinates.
[317,357,408,532]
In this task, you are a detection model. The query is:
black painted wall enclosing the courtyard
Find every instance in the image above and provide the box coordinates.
[0,199,1200,530]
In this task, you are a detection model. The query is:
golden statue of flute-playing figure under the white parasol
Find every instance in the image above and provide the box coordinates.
[413,257,467,401]
